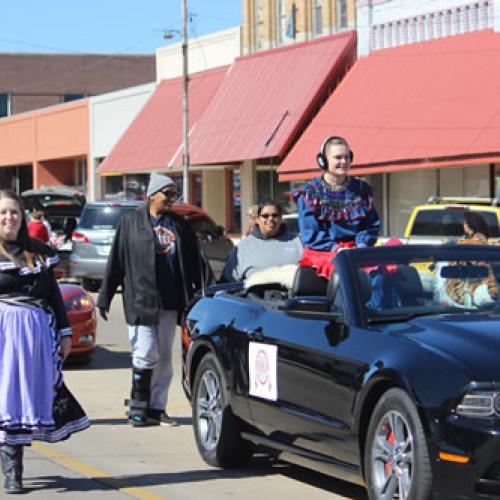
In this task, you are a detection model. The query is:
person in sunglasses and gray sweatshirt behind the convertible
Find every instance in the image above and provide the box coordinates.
[221,201,302,281]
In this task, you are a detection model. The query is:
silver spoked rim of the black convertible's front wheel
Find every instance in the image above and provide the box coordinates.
[371,411,415,500]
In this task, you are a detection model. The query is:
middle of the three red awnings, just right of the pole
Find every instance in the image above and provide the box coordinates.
[182,31,356,165]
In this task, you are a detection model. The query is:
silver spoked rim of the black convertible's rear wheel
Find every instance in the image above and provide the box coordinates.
[196,370,222,451]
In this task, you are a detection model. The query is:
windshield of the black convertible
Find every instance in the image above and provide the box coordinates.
[356,245,500,322]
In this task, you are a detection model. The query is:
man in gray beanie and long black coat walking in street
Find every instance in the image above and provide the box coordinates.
[97,173,202,427]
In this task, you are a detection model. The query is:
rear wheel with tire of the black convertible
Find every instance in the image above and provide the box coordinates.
[193,353,252,468]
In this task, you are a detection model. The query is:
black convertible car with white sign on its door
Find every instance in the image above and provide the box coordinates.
[183,245,500,500]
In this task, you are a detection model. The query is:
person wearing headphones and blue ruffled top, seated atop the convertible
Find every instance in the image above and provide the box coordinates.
[292,136,380,278]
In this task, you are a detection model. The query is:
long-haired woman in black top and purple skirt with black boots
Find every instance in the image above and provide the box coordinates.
[0,191,89,493]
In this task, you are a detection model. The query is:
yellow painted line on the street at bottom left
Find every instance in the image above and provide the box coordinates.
[32,442,165,500]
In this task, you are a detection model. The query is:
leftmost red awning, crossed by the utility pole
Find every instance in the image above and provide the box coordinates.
[97,66,227,174]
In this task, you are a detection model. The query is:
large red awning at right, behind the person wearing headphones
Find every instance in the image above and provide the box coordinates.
[278,30,500,181]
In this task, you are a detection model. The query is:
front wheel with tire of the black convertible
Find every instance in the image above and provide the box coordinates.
[364,388,432,500]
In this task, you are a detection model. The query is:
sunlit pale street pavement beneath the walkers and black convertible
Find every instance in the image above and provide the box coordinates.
[17,296,366,500]
